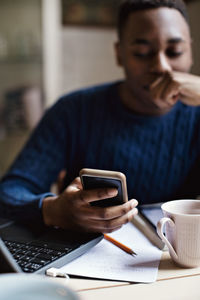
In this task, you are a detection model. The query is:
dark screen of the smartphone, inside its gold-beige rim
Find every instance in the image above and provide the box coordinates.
[82,175,124,207]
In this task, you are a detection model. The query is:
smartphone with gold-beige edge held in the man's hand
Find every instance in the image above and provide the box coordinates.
[79,169,128,207]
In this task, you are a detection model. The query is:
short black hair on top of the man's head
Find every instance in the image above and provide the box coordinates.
[117,0,189,39]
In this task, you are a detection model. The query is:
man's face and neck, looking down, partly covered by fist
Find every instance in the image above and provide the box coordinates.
[116,7,192,115]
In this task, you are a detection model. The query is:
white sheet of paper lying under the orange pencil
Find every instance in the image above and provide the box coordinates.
[61,223,162,283]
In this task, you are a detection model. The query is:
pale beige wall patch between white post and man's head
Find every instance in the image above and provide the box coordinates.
[62,27,122,92]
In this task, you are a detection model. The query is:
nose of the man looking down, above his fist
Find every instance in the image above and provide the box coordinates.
[150,52,172,75]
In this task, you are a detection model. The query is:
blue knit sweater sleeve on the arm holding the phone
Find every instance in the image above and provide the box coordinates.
[0,95,71,222]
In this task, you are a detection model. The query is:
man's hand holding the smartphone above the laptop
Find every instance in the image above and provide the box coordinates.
[42,177,138,233]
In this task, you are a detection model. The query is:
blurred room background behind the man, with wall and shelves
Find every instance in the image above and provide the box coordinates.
[0,0,200,177]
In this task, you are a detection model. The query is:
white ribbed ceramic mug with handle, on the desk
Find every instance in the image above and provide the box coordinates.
[157,199,200,267]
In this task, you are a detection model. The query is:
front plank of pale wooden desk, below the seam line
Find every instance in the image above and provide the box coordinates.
[79,275,200,300]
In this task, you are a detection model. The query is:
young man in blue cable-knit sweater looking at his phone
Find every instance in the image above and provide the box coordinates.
[0,0,200,232]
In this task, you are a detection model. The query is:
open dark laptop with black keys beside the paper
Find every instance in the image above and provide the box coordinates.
[0,219,103,274]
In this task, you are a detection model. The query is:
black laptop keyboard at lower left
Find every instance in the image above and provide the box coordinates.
[4,240,73,273]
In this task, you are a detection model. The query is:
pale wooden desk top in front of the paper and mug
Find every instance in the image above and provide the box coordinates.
[55,252,200,300]
